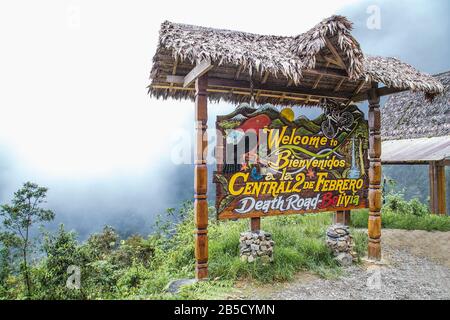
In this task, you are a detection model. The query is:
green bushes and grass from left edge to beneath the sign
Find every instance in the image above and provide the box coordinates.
[0,188,367,299]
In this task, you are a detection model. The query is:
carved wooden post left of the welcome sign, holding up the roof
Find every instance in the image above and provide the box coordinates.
[194,75,208,280]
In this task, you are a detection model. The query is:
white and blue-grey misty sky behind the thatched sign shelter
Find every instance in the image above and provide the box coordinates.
[0,0,450,238]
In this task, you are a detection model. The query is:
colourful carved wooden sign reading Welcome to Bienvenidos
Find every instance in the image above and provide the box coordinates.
[213,104,369,219]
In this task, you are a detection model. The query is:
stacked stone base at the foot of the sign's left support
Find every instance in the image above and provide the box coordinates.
[239,231,275,263]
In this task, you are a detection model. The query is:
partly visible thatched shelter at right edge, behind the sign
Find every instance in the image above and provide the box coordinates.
[381,71,450,214]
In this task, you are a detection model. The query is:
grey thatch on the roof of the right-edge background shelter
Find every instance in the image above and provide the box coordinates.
[381,71,450,140]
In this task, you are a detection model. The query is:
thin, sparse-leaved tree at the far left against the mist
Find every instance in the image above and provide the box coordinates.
[0,182,55,298]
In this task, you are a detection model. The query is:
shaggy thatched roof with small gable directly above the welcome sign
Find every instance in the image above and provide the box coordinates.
[149,16,442,104]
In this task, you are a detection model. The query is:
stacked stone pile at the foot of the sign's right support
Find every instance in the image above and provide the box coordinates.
[327,224,356,266]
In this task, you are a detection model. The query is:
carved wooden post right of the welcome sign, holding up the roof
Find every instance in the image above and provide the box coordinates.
[368,84,382,260]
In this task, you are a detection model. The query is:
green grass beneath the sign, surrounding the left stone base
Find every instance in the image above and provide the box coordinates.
[142,208,367,299]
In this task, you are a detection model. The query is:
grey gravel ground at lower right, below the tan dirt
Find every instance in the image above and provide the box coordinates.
[267,249,450,300]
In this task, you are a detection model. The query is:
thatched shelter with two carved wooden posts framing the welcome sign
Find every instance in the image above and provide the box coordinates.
[149,16,443,279]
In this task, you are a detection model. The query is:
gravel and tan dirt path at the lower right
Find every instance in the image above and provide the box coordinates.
[232,230,450,300]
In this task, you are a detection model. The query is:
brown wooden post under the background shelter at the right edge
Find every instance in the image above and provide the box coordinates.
[429,161,447,215]
